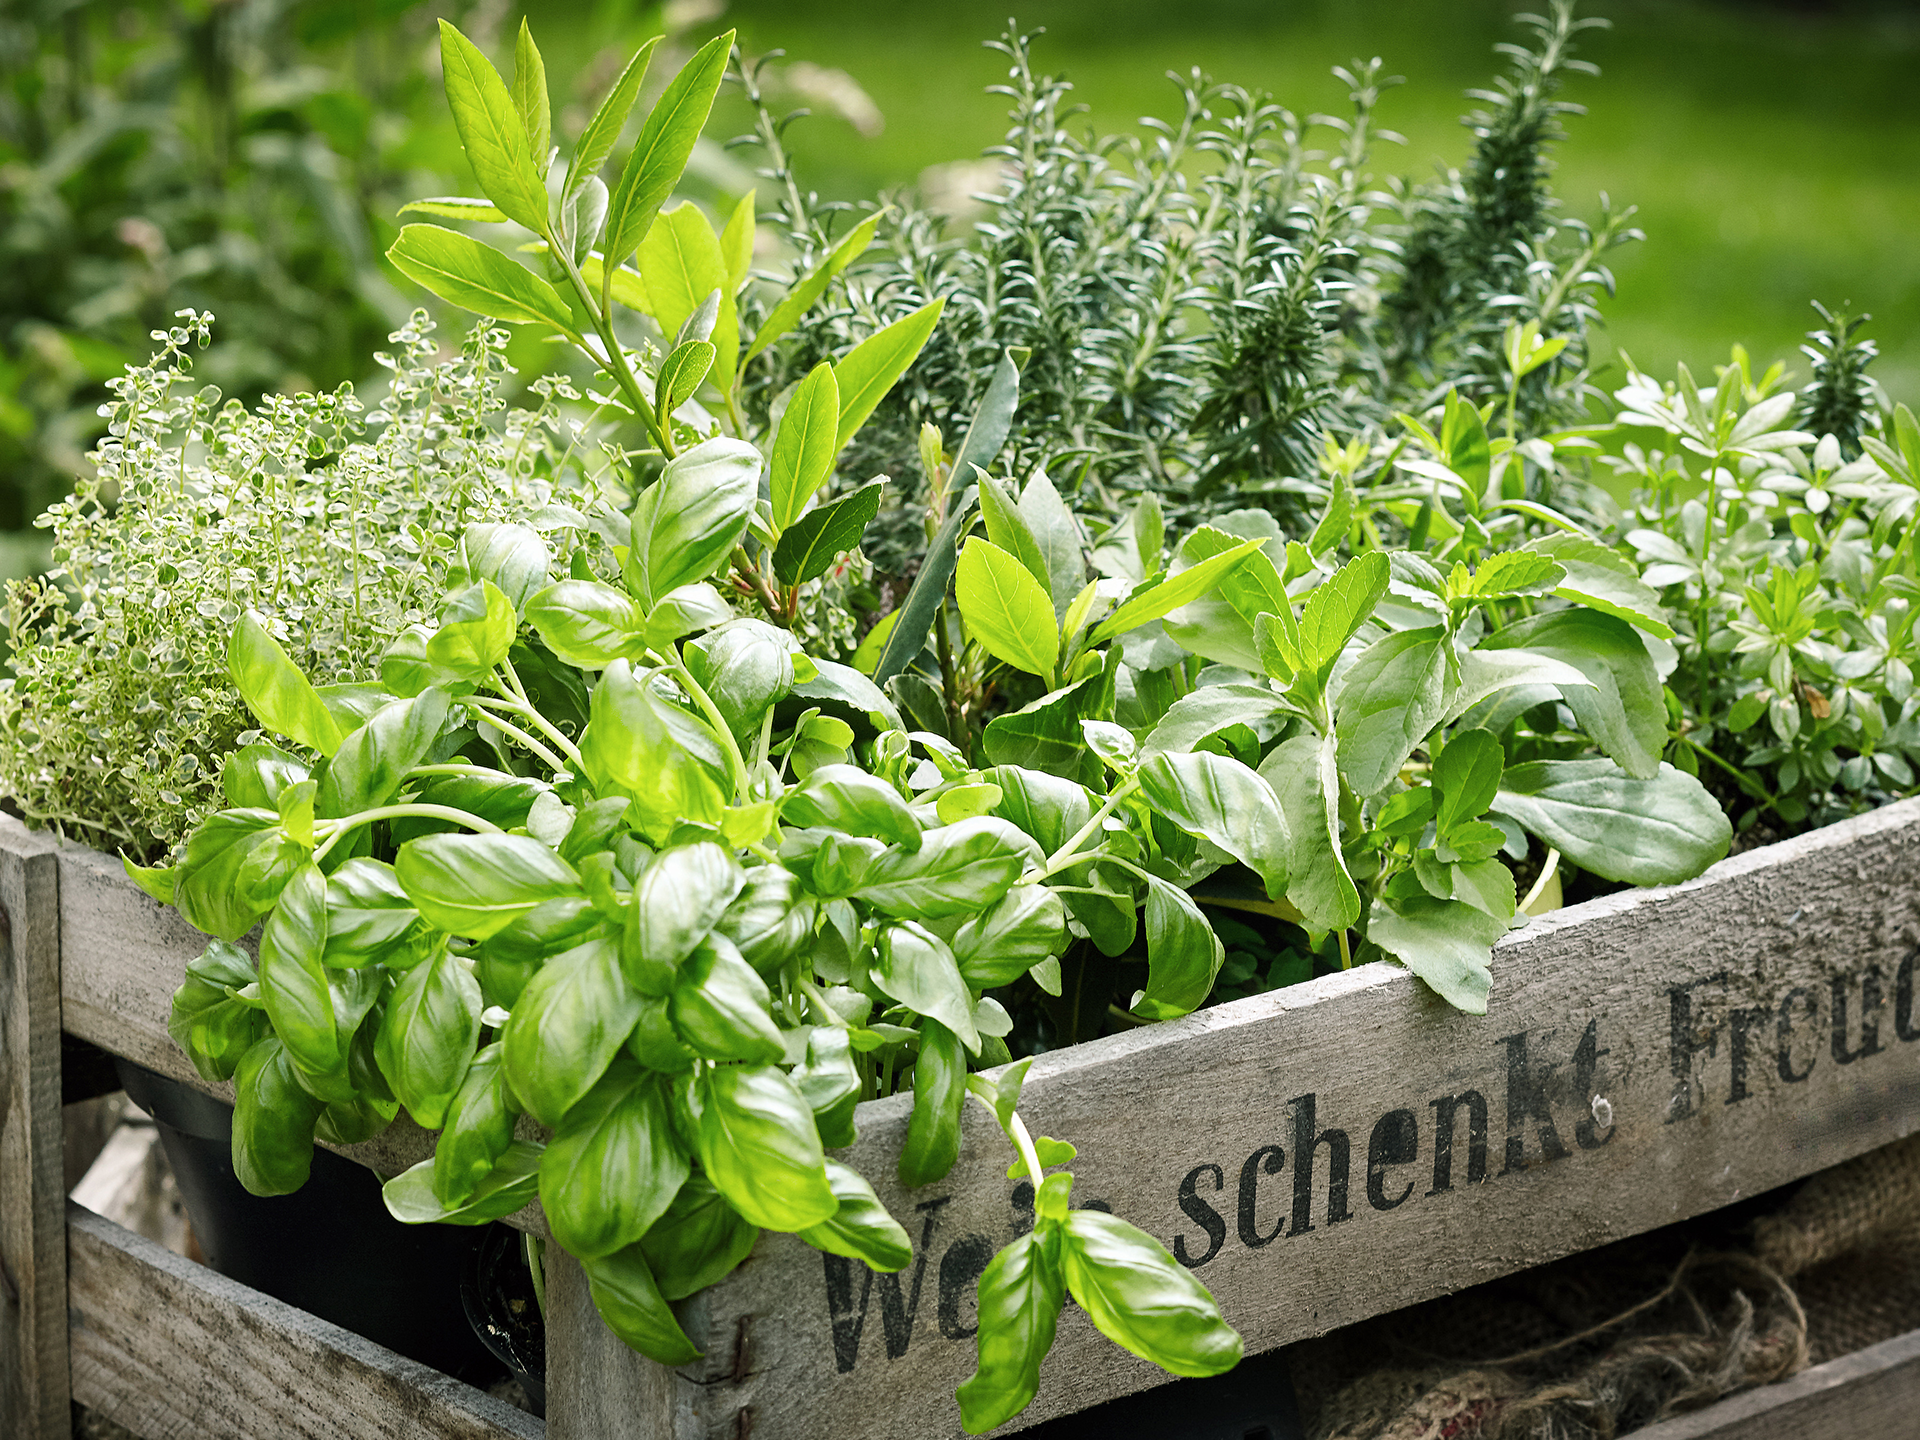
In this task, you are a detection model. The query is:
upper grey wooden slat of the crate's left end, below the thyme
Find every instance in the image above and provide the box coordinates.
[48,833,547,1235]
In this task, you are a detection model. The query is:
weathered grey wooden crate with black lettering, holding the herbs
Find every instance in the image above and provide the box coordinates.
[0,801,1920,1440]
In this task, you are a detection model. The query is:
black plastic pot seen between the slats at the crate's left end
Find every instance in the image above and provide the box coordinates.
[115,1060,499,1388]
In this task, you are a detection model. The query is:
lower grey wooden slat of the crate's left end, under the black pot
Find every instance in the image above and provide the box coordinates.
[67,1206,545,1440]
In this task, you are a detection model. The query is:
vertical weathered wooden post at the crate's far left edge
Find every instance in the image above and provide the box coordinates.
[0,820,71,1440]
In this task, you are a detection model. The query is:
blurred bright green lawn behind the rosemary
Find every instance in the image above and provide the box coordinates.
[714,0,1920,399]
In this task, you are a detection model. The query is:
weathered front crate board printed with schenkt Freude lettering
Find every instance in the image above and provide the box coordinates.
[664,803,1920,1440]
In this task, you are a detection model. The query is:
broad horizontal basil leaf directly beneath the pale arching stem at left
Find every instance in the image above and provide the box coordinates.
[394,833,580,941]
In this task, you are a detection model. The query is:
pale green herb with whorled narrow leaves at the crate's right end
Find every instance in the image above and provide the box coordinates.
[1611,311,1920,833]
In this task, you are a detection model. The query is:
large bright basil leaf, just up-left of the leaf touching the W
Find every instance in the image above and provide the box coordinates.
[682,1066,839,1231]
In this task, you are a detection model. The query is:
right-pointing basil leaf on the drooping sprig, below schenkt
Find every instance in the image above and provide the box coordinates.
[1062,1210,1240,1377]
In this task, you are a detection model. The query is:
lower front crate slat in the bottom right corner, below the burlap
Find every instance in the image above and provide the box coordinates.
[1634,1331,1920,1440]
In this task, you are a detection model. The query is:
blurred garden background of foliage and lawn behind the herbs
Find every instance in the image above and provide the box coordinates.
[0,0,1920,572]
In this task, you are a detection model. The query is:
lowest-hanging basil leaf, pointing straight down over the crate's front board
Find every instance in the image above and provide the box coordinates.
[954,1225,1066,1434]
